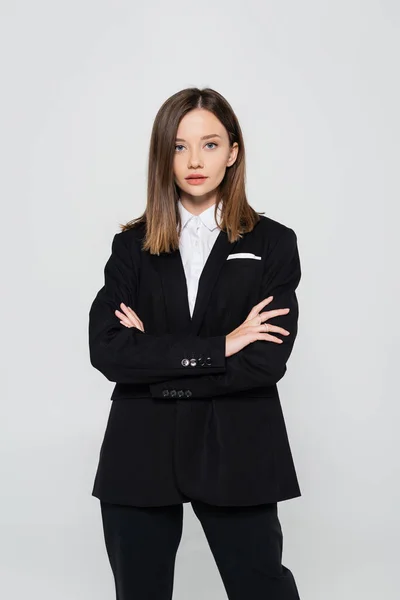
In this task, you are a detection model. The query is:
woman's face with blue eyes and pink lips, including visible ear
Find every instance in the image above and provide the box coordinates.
[174,108,239,205]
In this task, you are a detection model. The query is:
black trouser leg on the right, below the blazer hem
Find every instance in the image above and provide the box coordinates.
[192,501,300,600]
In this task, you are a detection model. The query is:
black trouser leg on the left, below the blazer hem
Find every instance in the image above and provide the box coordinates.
[100,501,183,600]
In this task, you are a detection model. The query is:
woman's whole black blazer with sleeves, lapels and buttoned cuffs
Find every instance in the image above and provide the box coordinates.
[89,215,301,506]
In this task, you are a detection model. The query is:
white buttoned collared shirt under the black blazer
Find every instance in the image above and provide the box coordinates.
[178,200,222,316]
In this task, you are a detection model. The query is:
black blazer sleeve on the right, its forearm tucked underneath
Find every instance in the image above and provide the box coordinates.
[150,227,301,398]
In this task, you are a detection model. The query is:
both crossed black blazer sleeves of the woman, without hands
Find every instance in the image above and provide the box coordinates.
[89,227,301,398]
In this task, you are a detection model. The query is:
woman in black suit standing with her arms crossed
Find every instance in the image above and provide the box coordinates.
[89,88,301,600]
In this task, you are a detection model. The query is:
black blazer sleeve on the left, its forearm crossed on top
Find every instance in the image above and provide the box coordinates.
[88,232,226,383]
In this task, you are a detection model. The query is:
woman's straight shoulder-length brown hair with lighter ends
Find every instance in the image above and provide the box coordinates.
[120,88,263,254]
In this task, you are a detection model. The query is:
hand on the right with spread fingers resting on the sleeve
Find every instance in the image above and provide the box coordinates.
[225,296,290,356]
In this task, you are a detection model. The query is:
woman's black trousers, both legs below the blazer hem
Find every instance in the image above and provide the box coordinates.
[100,500,300,600]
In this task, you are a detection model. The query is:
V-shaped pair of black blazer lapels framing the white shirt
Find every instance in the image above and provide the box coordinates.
[151,230,237,335]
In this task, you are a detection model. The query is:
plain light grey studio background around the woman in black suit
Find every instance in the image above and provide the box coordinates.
[0,0,400,600]
